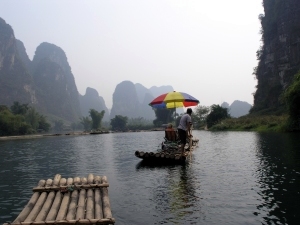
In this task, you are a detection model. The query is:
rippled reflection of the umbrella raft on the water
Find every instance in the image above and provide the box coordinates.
[136,161,200,224]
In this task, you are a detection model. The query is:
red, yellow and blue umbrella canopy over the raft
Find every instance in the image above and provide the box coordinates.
[149,91,199,109]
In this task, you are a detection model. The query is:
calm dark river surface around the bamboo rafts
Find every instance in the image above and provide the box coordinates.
[0,131,300,225]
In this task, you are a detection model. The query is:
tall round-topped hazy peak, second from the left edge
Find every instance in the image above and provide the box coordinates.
[32,42,81,121]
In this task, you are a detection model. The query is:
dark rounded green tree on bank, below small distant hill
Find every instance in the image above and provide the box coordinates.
[206,105,230,128]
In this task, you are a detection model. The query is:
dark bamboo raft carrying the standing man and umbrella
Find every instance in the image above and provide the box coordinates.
[134,139,199,163]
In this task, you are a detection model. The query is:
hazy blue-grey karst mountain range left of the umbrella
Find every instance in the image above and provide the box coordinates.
[0,18,251,122]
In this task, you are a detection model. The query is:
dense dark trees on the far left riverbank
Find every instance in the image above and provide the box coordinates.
[0,102,51,136]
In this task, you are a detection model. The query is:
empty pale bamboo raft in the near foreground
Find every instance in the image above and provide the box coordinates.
[4,174,115,225]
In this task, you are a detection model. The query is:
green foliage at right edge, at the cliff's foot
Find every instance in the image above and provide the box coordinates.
[283,71,300,131]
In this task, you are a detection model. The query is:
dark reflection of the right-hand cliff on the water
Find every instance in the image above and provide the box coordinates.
[254,134,300,224]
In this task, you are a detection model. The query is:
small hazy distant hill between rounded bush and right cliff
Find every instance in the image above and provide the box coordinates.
[221,100,252,118]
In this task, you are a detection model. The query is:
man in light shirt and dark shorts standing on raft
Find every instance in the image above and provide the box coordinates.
[177,108,193,155]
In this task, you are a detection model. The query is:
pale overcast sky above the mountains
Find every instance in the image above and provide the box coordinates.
[0,0,264,108]
